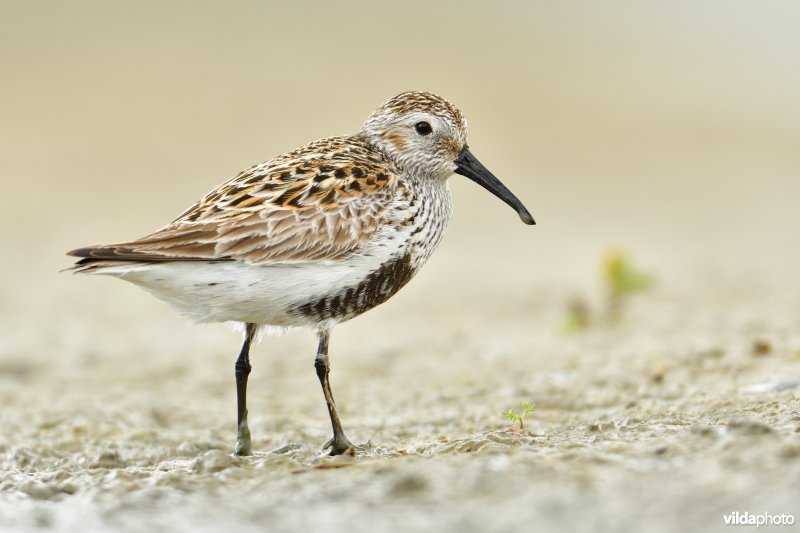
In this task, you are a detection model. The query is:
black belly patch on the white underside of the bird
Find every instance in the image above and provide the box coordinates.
[294,254,416,320]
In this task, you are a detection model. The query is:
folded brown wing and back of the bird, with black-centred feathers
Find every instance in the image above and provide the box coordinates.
[69,137,397,266]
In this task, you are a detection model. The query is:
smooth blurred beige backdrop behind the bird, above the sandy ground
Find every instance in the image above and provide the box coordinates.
[0,1,800,292]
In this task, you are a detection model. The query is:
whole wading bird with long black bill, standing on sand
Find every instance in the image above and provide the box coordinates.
[67,91,535,456]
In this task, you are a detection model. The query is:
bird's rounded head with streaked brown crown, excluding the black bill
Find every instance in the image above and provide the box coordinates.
[359,91,467,179]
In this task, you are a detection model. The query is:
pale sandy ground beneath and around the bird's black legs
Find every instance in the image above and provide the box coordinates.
[0,252,800,532]
